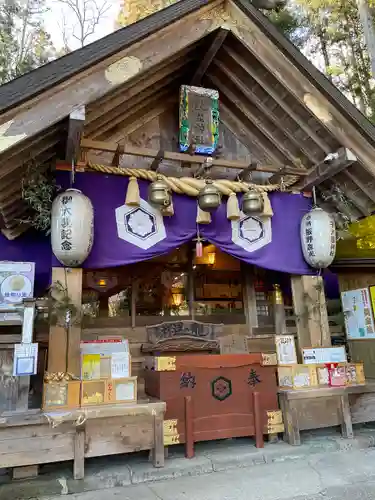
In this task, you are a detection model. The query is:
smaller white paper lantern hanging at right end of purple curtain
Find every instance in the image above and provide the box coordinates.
[301,207,336,269]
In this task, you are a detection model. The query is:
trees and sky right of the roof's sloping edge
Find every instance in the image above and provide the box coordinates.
[269,0,375,120]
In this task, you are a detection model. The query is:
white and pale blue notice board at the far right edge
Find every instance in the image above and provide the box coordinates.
[341,288,375,339]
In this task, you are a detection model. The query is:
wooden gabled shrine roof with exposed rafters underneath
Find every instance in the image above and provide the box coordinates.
[0,0,375,238]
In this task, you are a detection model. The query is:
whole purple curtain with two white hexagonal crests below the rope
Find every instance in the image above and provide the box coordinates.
[0,172,315,278]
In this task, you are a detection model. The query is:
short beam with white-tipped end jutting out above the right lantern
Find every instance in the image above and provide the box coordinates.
[298,148,357,191]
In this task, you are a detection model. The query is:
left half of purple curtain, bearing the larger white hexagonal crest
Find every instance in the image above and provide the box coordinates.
[53,173,196,269]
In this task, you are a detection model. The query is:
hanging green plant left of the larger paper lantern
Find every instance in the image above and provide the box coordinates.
[21,160,60,234]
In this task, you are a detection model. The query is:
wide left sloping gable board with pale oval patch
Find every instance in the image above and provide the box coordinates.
[0,2,217,153]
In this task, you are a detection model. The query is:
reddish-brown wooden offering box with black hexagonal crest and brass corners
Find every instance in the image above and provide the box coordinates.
[145,353,284,458]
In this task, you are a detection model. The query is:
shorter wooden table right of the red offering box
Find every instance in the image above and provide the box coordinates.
[279,386,356,446]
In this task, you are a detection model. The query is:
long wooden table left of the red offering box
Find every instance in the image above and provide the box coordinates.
[0,400,166,479]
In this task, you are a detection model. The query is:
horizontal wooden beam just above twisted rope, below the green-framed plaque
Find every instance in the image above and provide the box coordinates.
[81,138,304,175]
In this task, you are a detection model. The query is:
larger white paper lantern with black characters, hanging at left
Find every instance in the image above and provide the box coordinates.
[51,189,94,267]
